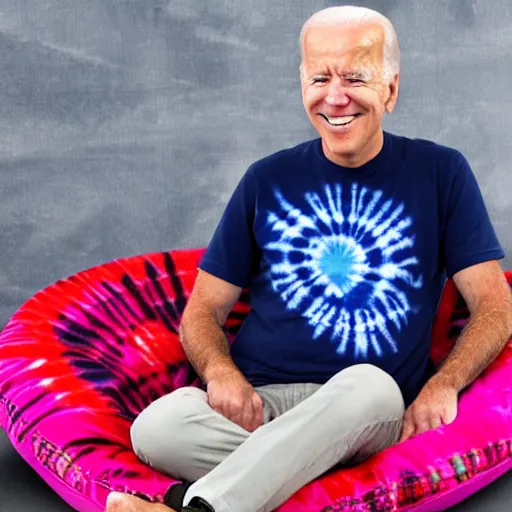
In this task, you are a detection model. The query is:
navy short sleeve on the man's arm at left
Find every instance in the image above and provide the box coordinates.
[199,168,258,288]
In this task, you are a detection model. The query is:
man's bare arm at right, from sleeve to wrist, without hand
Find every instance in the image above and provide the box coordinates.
[432,261,512,392]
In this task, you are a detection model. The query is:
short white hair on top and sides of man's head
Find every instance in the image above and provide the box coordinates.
[299,5,400,81]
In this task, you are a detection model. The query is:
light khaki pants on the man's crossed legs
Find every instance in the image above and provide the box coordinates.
[131,364,404,512]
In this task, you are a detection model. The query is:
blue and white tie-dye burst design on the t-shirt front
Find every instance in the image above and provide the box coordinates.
[265,184,423,359]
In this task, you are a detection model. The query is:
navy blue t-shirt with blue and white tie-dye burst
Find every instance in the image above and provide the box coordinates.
[199,132,504,403]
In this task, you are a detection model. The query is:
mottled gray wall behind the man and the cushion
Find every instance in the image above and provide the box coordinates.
[0,0,512,326]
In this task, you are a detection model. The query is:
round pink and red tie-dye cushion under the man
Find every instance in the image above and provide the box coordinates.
[0,249,512,512]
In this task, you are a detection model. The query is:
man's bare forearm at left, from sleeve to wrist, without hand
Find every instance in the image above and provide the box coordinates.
[180,270,242,384]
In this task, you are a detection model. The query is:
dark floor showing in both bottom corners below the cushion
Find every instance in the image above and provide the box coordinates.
[0,430,512,512]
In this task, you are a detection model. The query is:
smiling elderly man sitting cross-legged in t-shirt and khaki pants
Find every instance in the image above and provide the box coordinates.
[107,7,512,512]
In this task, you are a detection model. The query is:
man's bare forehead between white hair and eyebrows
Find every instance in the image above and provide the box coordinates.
[302,23,384,69]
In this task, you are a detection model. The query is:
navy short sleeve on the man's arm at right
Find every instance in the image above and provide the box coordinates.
[442,152,505,278]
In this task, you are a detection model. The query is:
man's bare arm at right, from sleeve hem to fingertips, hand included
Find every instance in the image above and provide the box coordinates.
[400,261,512,441]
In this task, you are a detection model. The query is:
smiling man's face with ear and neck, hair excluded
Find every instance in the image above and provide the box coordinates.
[301,23,399,167]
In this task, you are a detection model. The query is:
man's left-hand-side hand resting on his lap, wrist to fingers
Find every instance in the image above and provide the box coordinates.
[207,371,263,432]
